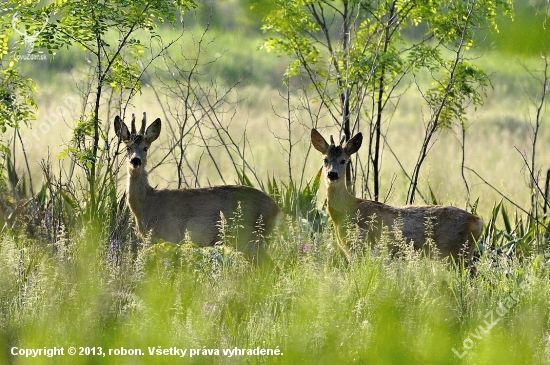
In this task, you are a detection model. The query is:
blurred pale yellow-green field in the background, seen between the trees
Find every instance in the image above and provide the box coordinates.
[10,1,549,214]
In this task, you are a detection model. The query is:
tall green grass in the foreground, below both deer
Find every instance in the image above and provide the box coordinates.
[0,212,550,364]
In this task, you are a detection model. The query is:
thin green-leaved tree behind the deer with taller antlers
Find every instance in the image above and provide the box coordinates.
[0,0,195,218]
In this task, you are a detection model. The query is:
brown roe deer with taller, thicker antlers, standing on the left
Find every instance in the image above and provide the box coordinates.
[114,113,282,260]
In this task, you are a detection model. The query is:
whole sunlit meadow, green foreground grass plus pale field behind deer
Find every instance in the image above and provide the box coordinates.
[0,1,550,364]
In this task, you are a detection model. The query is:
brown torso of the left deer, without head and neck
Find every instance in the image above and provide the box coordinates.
[138,185,281,246]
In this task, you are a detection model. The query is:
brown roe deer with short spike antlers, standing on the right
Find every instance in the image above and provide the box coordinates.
[311,129,483,263]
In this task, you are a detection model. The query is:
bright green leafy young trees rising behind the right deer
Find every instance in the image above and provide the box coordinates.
[263,0,511,203]
